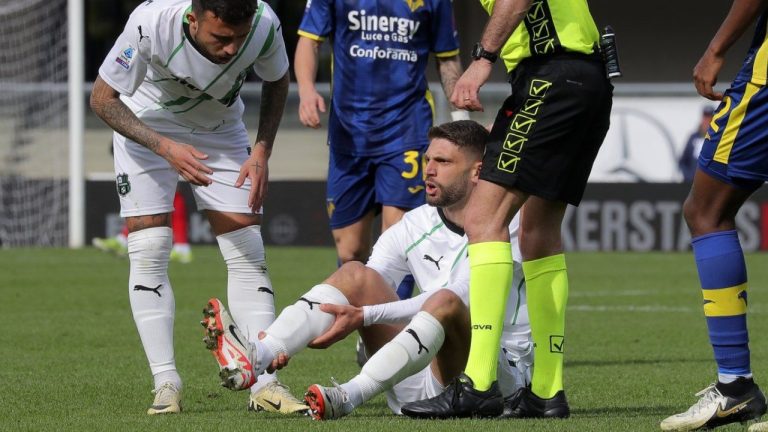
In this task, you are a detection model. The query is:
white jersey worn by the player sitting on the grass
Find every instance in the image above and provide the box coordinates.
[366,204,521,301]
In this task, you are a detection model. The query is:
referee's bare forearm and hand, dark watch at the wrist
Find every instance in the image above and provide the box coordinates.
[451,0,531,111]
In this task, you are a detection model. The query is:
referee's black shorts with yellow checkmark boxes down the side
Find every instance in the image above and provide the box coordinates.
[480,53,613,205]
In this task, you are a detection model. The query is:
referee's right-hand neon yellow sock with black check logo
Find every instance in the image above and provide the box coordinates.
[523,254,568,399]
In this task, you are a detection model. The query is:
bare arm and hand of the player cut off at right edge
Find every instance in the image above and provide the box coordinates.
[693,0,766,100]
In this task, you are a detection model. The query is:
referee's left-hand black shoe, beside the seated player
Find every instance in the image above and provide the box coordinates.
[400,373,504,419]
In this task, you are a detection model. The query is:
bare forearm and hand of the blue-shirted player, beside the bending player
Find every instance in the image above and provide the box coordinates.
[293,36,325,129]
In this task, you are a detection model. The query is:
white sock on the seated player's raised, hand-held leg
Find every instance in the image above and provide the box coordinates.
[261,284,349,357]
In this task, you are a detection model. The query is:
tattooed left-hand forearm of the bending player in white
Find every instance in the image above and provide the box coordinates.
[91,78,164,156]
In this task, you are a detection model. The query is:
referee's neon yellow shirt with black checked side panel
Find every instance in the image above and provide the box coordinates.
[480,0,600,72]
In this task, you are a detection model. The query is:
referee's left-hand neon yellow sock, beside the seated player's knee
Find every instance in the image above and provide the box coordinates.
[464,242,512,391]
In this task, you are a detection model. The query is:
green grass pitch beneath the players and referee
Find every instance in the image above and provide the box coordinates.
[0,247,768,432]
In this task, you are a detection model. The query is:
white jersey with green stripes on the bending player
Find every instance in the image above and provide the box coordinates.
[99,0,288,132]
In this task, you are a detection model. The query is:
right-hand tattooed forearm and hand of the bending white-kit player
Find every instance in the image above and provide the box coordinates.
[235,72,290,213]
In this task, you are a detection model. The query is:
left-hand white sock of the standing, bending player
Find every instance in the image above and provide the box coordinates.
[128,227,181,387]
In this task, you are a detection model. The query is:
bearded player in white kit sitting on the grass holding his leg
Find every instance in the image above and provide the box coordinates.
[203,120,532,420]
